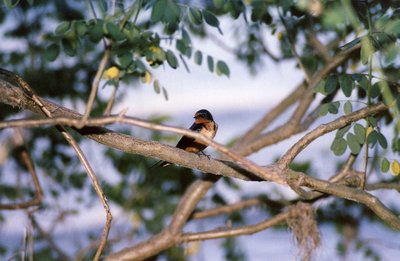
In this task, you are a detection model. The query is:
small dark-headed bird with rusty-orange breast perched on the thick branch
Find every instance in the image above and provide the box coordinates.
[155,109,218,167]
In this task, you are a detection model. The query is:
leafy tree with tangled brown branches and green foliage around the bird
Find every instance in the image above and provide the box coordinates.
[0,0,400,260]
